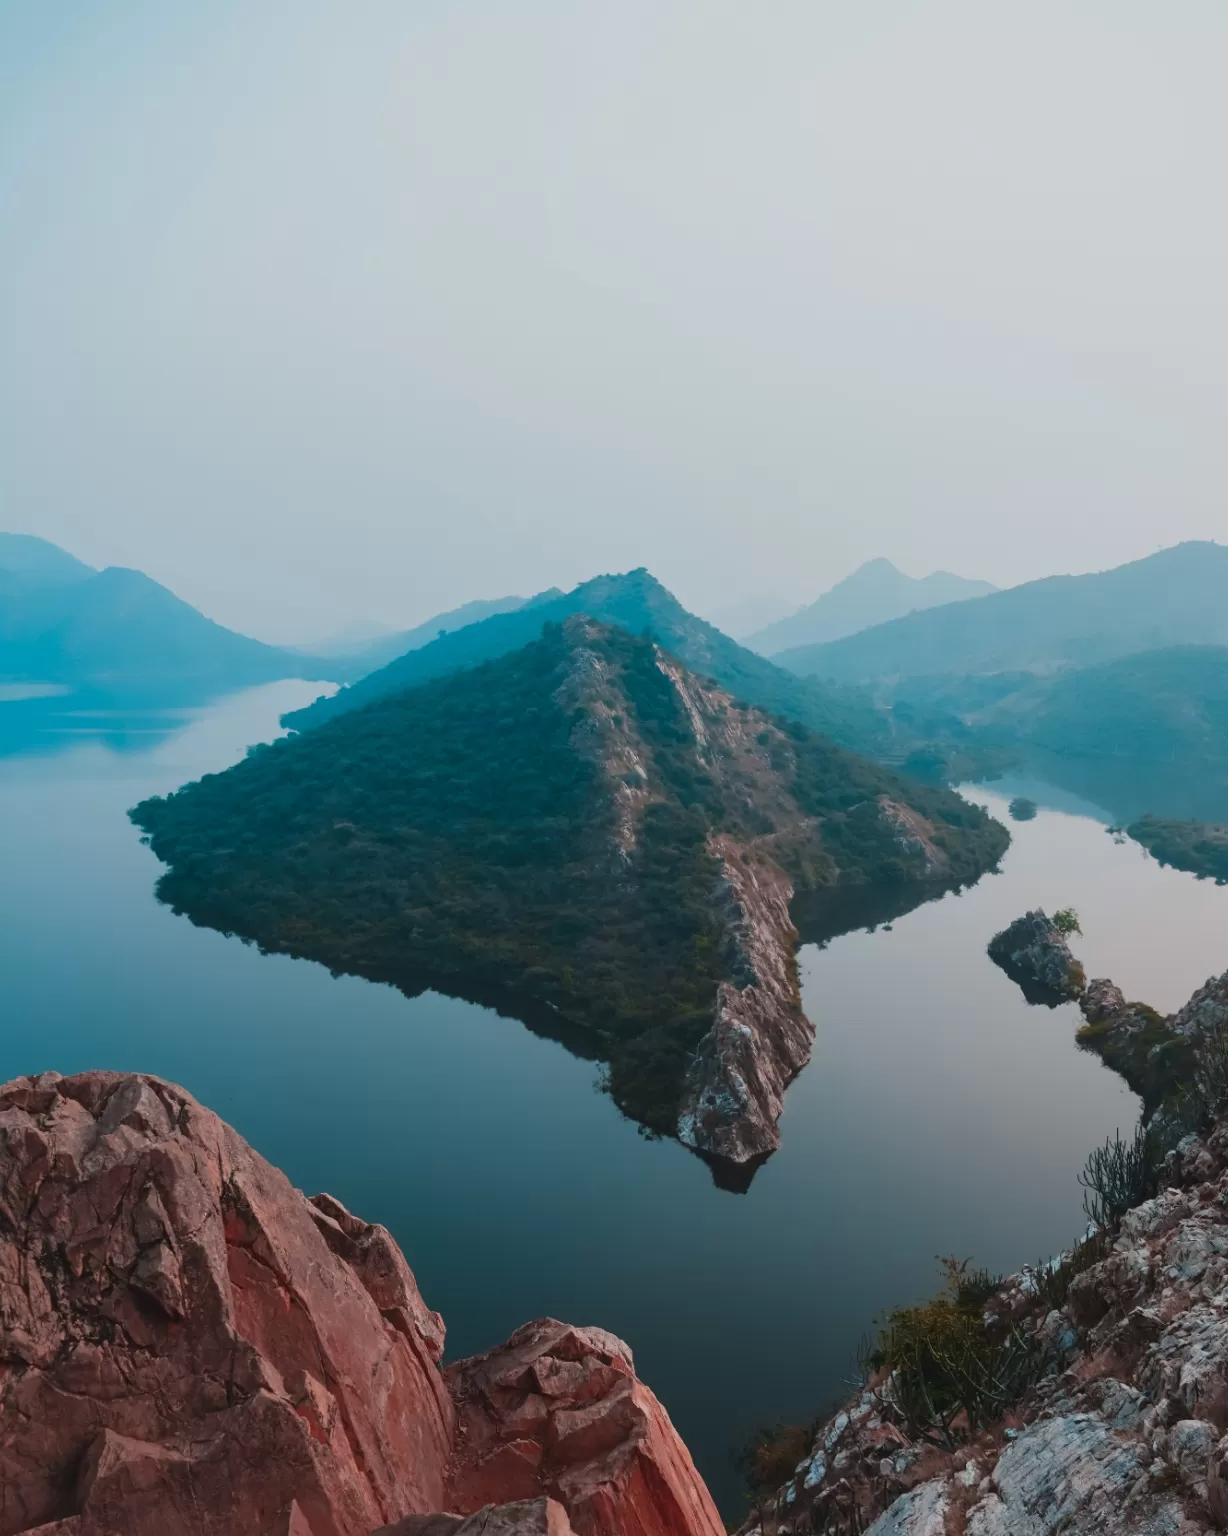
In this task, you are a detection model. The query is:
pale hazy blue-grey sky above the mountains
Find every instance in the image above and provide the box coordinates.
[0,0,1228,639]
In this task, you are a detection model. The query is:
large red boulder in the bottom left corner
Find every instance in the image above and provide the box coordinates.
[0,1072,453,1536]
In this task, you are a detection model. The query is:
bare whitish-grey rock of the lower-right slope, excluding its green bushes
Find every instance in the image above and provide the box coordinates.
[742,1121,1228,1536]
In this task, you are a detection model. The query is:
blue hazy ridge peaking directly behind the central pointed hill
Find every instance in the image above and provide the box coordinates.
[283,570,890,753]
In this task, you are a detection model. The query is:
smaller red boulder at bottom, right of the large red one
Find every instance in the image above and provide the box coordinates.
[447,1318,724,1536]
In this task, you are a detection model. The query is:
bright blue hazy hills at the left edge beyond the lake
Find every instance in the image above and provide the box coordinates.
[0,533,329,688]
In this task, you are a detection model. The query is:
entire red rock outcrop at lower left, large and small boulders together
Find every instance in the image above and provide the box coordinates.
[0,1072,722,1536]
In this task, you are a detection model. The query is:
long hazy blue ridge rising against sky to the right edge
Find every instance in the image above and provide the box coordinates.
[776,542,1228,682]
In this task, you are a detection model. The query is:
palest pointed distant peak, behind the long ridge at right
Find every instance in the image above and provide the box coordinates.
[742,559,997,656]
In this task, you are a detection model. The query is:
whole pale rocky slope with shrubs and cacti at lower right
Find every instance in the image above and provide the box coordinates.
[742,972,1228,1536]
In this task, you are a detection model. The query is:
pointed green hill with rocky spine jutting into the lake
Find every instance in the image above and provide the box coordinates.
[131,614,1008,1170]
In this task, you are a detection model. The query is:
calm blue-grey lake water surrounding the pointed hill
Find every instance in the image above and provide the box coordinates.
[0,684,1228,1514]
